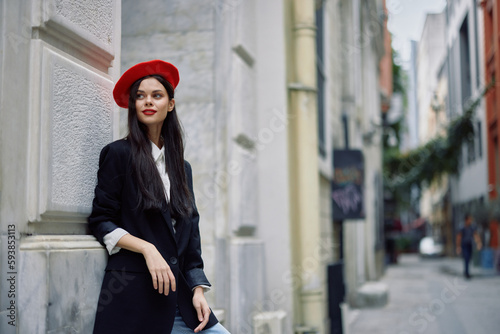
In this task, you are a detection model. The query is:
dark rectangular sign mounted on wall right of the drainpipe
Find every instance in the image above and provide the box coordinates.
[332,150,365,220]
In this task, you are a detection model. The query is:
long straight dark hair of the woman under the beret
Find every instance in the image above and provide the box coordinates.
[127,75,194,217]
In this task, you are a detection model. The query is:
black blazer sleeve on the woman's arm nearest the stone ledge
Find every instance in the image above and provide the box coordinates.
[88,144,127,246]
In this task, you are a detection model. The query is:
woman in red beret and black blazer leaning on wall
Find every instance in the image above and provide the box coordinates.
[88,60,228,334]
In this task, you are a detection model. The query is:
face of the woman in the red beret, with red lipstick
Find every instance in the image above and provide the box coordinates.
[135,78,175,129]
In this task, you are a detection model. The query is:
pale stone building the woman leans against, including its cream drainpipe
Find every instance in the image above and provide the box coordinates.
[0,0,390,334]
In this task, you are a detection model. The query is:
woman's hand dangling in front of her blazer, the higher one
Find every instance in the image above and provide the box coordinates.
[142,244,176,296]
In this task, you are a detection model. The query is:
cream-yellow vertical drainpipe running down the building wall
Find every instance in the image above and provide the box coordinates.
[288,0,326,332]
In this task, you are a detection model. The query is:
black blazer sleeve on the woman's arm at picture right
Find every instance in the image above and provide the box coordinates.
[183,161,211,289]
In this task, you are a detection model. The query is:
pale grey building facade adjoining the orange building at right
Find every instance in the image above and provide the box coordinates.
[446,0,488,233]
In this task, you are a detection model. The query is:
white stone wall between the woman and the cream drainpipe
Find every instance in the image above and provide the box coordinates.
[121,0,292,333]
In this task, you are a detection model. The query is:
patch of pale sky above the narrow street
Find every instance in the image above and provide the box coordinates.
[386,0,446,67]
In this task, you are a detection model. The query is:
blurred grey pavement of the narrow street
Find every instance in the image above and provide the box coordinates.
[345,255,500,334]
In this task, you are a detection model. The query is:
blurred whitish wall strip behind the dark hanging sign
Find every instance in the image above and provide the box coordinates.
[333,0,383,305]
